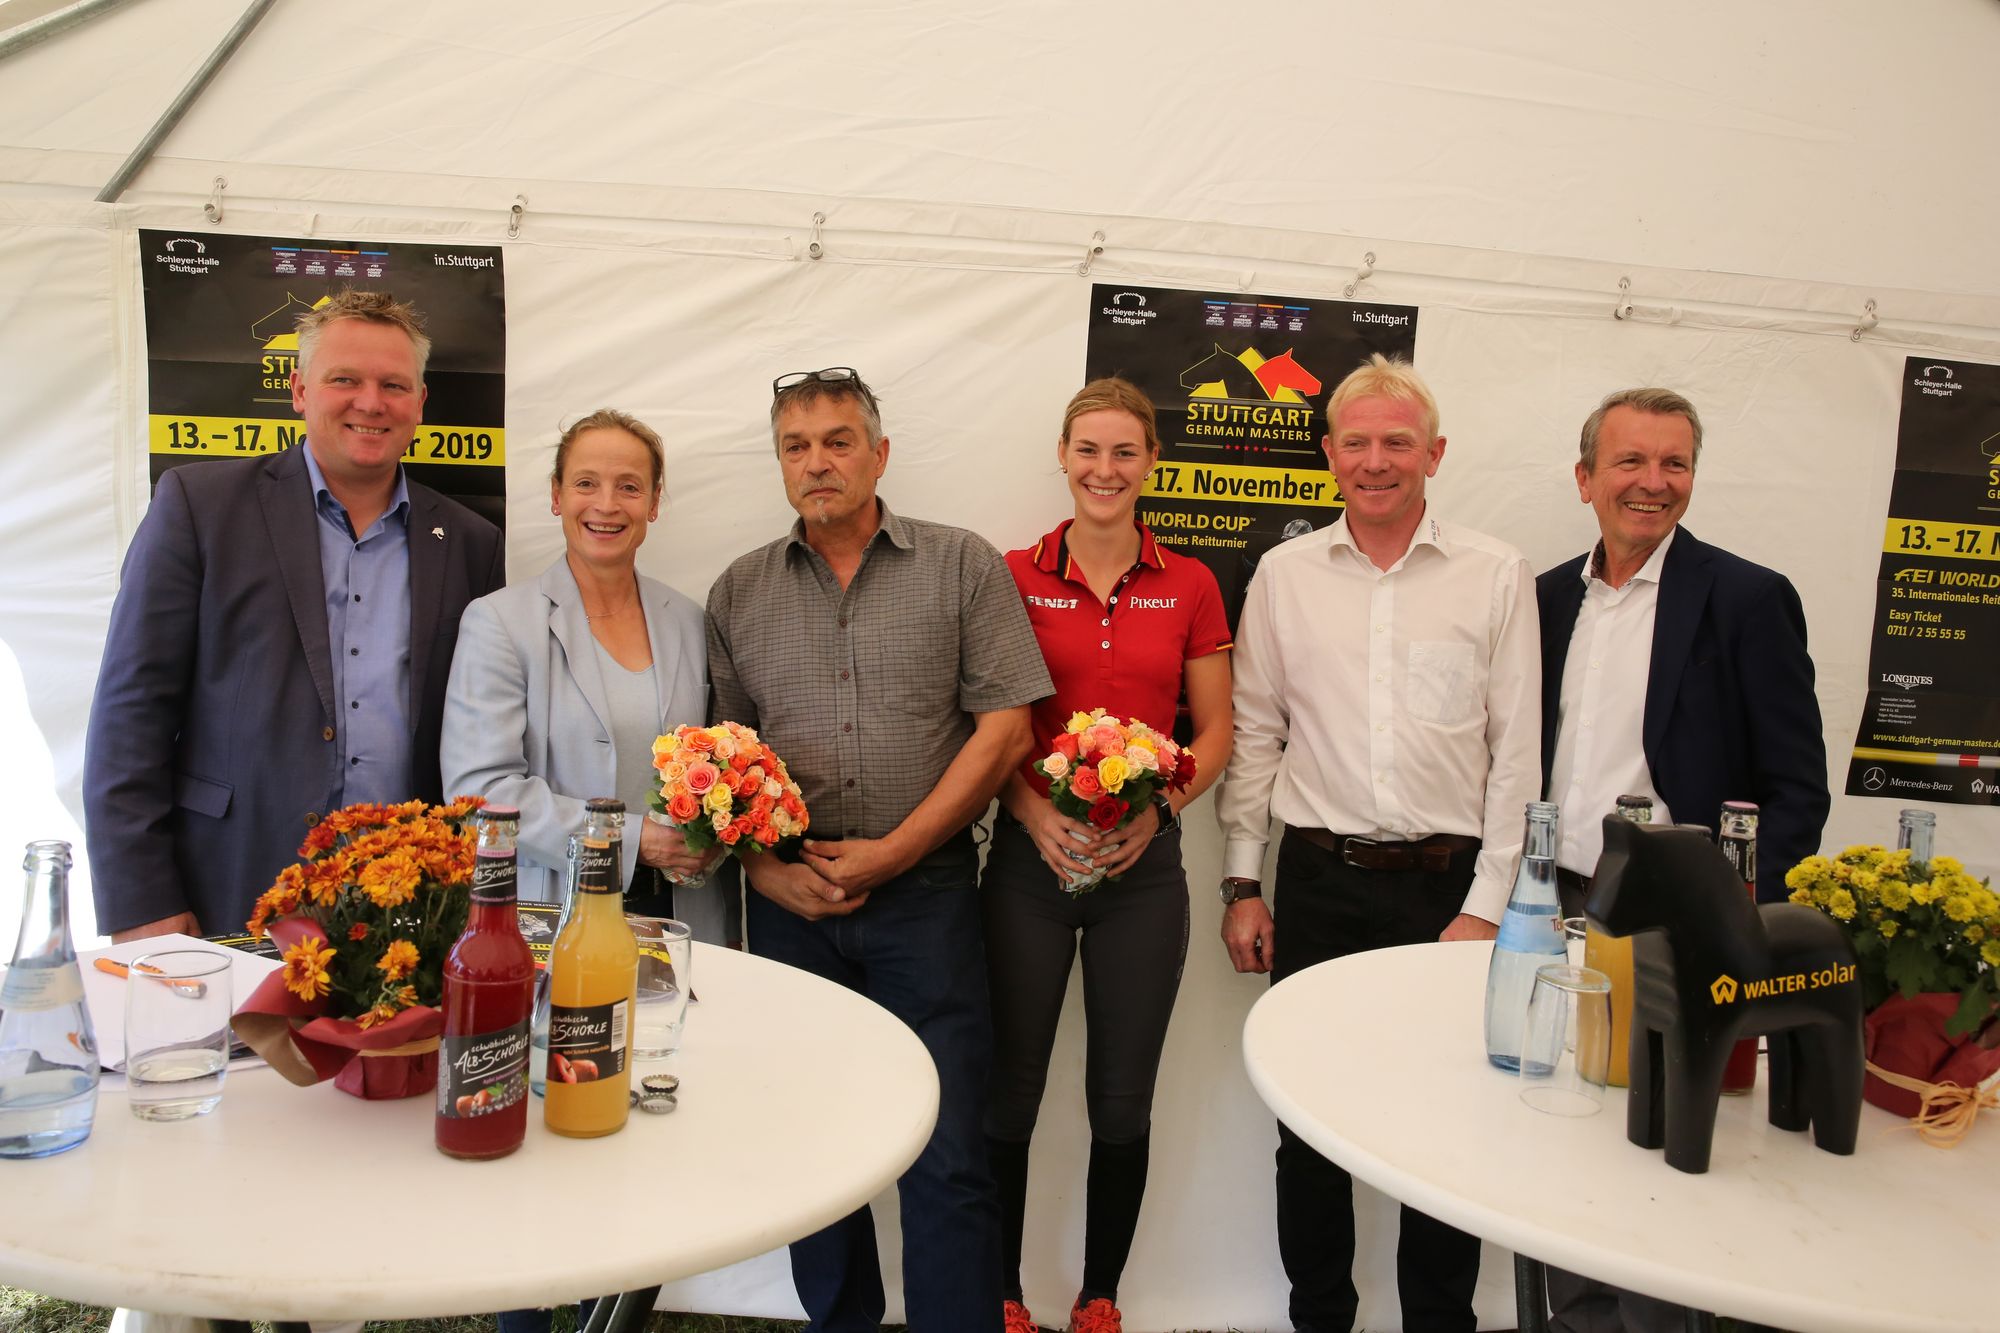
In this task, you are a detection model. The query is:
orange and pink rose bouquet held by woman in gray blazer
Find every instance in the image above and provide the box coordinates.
[646,723,810,857]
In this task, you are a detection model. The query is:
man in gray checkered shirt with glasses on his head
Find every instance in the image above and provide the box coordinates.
[708,366,1054,1333]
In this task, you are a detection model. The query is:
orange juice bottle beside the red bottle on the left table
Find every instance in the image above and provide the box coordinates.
[542,797,638,1139]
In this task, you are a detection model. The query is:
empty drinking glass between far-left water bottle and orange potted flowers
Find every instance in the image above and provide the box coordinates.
[126,949,234,1121]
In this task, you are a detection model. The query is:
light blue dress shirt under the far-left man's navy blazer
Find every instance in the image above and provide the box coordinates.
[298,444,416,807]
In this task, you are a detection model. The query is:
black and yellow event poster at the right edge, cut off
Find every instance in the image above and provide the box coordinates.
[1848,356,2000,805]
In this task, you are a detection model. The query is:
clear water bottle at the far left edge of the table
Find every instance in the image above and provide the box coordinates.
[0,843,98,1157]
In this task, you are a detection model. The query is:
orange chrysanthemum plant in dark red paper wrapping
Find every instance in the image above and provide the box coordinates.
[236,797,482,1099]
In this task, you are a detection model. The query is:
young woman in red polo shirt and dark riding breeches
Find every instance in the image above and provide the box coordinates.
[982,378,1230,1333]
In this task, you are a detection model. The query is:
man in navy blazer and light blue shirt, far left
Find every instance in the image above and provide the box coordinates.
[84,292,506,939]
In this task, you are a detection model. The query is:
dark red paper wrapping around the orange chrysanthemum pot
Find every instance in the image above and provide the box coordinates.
[234,917,444,1101]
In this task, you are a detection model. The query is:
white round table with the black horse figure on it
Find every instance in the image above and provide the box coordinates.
[1244,943,2000,1333]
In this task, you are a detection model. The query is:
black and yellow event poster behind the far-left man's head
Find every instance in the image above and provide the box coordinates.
[140,230,506,526]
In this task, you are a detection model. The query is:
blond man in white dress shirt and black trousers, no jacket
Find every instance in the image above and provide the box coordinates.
[1220,356,1542,1333]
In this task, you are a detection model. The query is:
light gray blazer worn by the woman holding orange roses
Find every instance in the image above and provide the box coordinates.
[438,558,736,945]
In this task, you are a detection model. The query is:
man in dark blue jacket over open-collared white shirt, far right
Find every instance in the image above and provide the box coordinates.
[1536,388,1832,1333]
